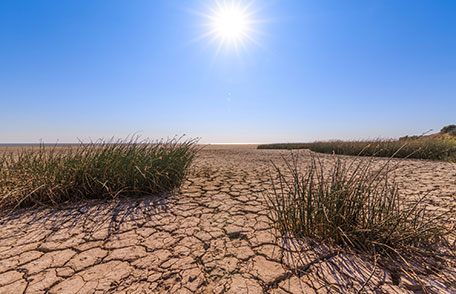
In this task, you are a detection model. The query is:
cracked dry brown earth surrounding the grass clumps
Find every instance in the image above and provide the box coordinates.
[0,146,456,293]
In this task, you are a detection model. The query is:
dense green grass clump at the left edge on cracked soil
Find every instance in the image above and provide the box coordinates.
[0,139,196,209]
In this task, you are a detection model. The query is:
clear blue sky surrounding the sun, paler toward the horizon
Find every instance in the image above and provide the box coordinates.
[0,0,456,143]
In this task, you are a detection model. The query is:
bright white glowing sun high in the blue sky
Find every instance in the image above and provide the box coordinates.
[204,0,256,51]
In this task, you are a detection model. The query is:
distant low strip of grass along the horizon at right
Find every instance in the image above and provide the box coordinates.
[258,136,456,161]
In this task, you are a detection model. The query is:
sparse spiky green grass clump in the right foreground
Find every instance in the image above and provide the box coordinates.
[268,156,451,256]
